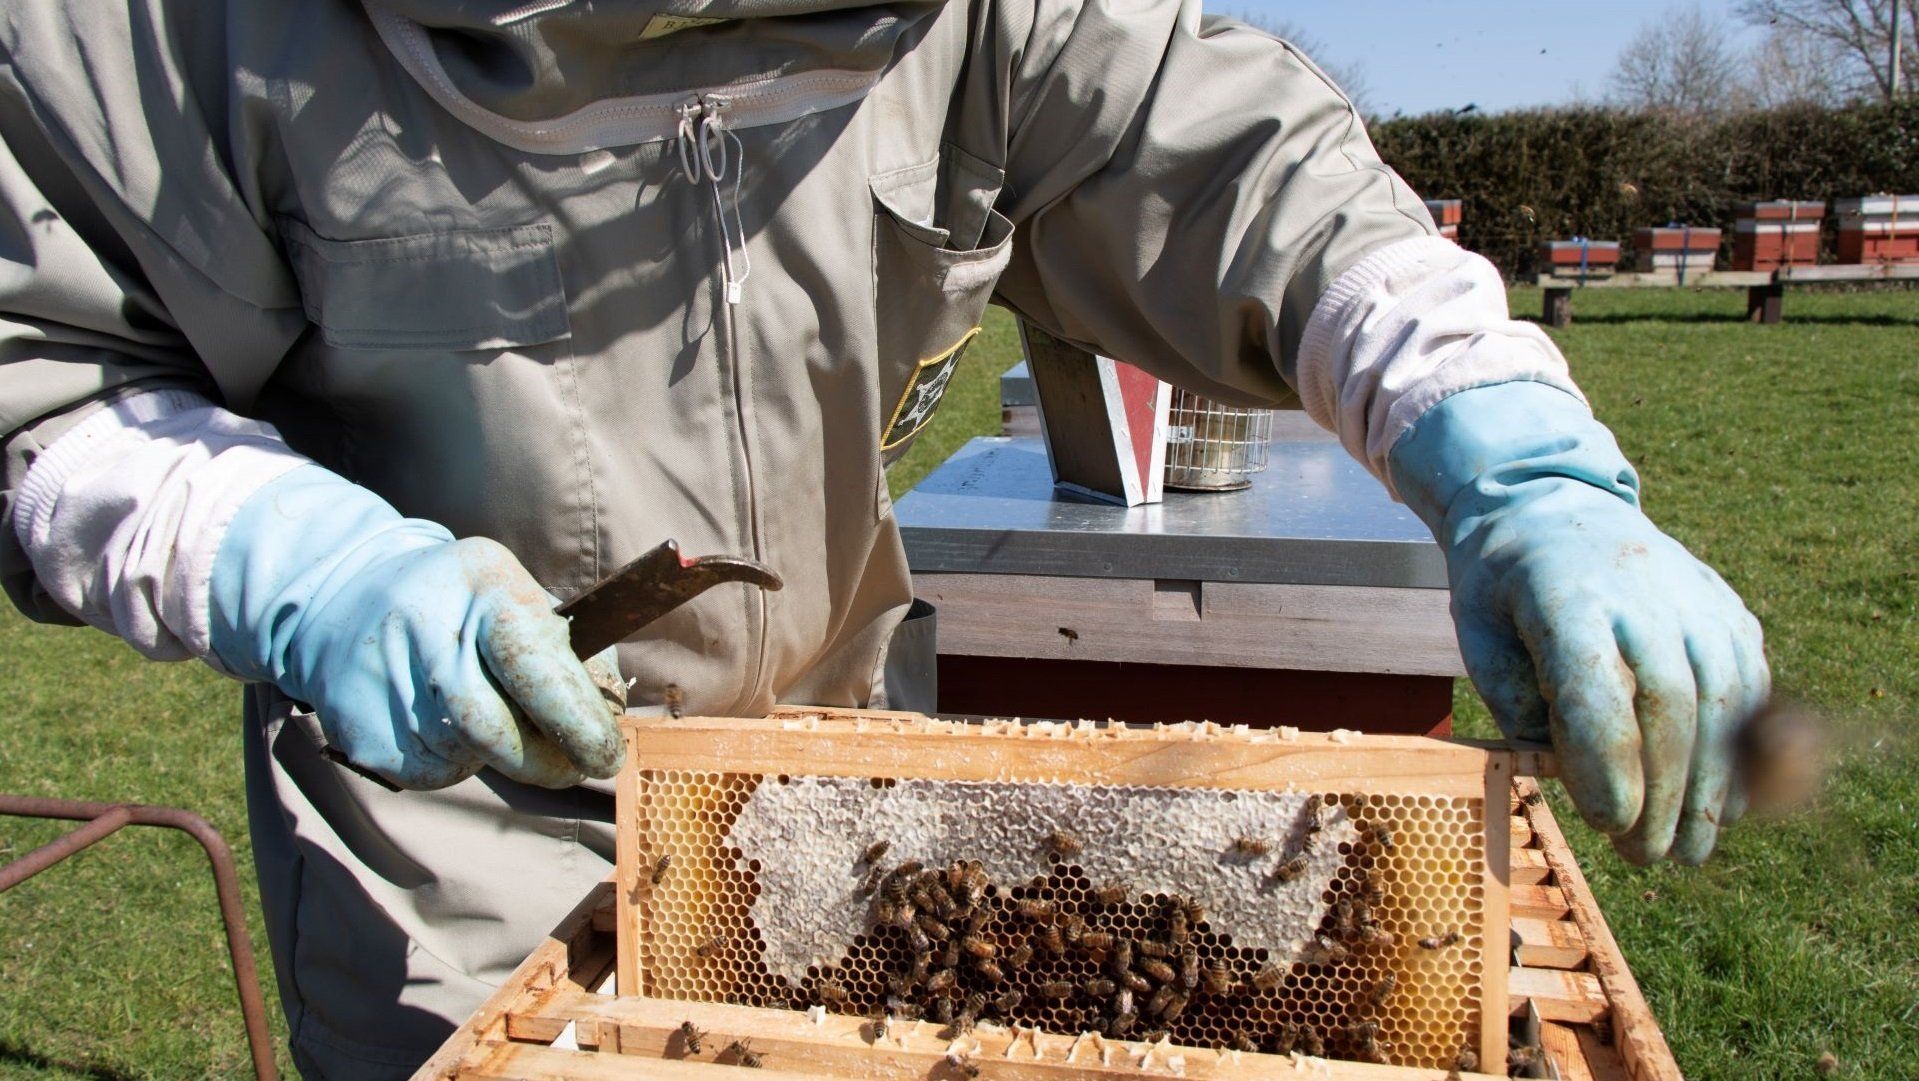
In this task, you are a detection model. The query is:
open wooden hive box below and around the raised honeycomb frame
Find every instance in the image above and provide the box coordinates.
[415,737,1681,1081]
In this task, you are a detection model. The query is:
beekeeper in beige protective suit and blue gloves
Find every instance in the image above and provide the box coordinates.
[0,0,1767,1077]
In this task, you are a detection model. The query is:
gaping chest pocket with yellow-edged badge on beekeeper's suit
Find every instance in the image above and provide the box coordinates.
[871,146,1013,463]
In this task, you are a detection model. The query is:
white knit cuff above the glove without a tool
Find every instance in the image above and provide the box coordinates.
[1295,236,1585,499]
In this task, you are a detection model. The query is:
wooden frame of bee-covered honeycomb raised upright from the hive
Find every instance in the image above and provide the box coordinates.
[620,718,1504,1068]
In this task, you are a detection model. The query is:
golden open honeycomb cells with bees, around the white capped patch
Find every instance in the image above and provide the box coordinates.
[635,770,1485,1069]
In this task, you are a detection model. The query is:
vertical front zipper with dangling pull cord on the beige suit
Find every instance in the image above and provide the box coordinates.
[675,94,768,709]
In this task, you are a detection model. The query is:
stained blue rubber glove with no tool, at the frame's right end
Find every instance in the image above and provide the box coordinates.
[1389,382,1771,864]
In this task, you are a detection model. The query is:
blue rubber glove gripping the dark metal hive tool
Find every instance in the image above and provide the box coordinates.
[209,465,624,789]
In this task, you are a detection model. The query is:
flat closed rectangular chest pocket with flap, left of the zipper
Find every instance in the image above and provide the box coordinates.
[280,221,572,349]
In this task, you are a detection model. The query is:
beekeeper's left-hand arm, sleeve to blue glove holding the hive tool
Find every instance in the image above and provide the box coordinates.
[0,63,618,787]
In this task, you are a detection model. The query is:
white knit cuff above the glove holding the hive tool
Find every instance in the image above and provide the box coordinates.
[12,390,307,661]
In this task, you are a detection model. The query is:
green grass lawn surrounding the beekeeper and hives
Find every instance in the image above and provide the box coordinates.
[0,290,1919,1081]
